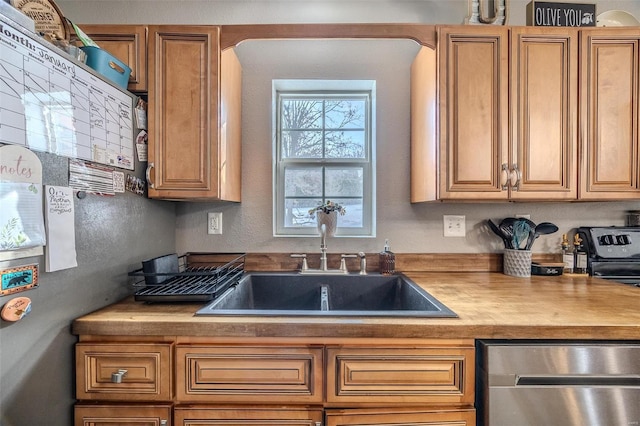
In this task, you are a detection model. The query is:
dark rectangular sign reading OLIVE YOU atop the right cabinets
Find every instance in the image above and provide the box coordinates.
[527,1,596,27]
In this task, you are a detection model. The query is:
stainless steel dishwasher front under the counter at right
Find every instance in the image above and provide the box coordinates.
[476,340,640,426]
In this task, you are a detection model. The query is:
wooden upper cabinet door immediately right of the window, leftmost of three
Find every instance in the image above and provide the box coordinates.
[438,26,509,200]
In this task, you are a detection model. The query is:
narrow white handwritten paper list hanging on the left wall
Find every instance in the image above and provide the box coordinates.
[44,185,78,272]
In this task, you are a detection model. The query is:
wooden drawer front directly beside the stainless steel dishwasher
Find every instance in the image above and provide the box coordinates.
[326,346,475,406]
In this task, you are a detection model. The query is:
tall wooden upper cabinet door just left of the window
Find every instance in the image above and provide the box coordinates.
[147,26,235,200]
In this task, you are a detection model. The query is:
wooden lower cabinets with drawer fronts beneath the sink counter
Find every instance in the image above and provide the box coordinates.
[75,336,475,426]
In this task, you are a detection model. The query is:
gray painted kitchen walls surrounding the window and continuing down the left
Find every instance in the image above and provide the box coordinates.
[0,0,640,426]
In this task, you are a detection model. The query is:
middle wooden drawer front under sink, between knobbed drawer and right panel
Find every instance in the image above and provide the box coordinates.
[176,346,323,404]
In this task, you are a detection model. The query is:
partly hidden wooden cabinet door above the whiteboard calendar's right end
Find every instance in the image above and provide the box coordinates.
[79,25,147,92]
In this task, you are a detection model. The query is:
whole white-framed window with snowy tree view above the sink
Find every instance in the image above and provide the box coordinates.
[274,81,375,236]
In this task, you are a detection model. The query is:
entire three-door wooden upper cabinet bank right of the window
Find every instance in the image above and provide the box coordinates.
[411,26,640,202]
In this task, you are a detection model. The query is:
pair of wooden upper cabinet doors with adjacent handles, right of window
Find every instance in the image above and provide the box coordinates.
[428,26,578,201]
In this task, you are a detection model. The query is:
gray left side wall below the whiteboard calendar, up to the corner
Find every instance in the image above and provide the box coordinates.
[0,153,175,426]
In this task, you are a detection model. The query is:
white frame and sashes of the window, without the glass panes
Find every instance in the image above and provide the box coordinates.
[272,80,376,237]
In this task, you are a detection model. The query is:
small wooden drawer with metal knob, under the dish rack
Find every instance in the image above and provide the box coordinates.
[76,343,172,401]
